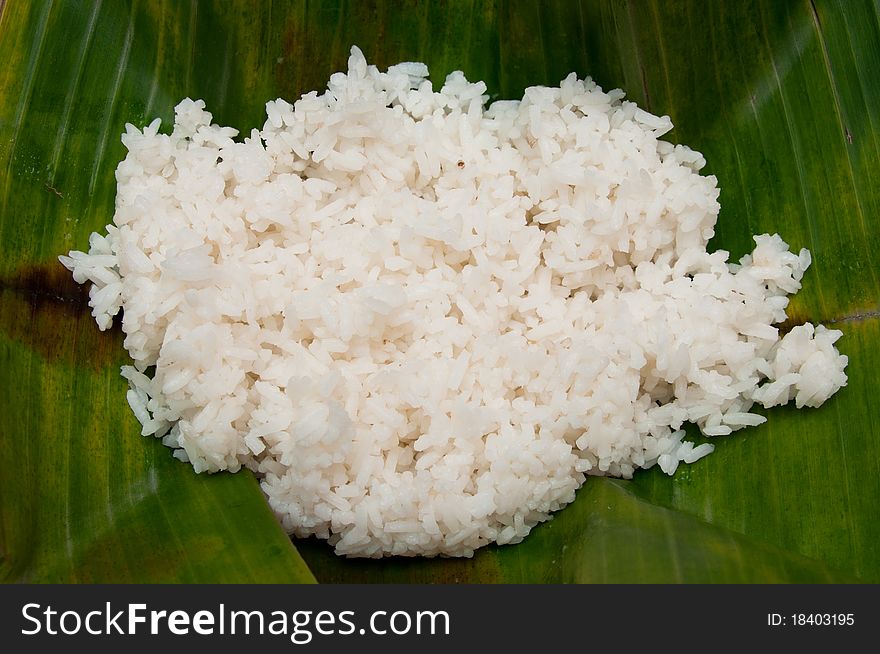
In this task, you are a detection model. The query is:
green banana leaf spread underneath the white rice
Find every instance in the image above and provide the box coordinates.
[0,0,880,583]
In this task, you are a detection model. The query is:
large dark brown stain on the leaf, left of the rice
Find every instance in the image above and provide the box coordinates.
[0,261,123,370]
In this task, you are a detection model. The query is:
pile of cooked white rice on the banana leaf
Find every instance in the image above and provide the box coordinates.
[61,48,847,557]
